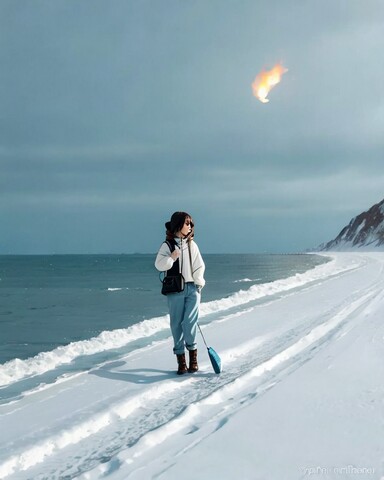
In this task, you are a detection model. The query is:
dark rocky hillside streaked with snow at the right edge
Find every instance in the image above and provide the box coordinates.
[319,200,384,251]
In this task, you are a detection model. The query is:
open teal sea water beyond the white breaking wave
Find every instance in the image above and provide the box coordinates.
[0,254,326,369]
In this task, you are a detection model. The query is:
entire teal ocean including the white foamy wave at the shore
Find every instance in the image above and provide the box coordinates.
[0,254,327,401]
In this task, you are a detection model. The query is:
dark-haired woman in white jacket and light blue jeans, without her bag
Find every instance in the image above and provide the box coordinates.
[155,212,205,375]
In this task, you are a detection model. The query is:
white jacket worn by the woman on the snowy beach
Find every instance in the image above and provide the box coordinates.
[155,238,205,287]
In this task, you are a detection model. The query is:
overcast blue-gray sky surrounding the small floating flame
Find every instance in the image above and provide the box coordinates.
[0,0,384,253]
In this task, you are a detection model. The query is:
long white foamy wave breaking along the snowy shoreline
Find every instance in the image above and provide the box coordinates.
[0,253,359,387]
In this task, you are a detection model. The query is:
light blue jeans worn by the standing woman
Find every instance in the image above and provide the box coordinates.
[167,282,200,355]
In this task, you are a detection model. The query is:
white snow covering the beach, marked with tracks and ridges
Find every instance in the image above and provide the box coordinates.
[0,252,384,480]
